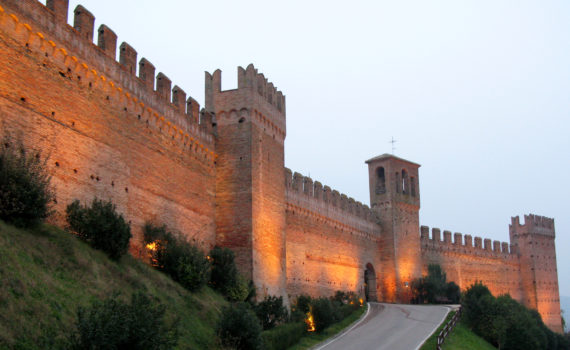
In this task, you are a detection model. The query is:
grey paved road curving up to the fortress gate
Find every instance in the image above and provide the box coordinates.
[314,303,449,350]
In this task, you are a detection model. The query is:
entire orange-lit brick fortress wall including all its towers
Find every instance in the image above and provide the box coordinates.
[0,0,561,331]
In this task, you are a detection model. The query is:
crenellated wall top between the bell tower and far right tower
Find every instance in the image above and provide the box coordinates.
[420,226,516,257]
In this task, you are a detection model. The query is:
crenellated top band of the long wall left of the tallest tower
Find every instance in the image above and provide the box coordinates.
[0,0,214,149]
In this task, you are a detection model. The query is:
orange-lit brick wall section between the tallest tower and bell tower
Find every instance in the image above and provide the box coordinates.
[285,169,383,300]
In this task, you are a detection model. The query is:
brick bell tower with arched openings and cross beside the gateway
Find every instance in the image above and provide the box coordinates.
[366,154,421,302]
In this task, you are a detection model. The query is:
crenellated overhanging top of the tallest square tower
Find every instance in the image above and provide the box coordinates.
[205,64,286,140]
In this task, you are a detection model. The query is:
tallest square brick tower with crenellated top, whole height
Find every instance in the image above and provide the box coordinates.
[205,64,287,301]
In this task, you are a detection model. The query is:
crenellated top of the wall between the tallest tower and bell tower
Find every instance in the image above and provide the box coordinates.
[284,168,379,238]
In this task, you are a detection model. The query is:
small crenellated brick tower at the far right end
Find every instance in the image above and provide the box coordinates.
[509,214,563,333]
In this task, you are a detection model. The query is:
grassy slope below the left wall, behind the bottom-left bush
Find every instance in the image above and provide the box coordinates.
[0,221,226,349]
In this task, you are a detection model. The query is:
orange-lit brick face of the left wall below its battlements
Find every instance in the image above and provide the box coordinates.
[0,1,215,253]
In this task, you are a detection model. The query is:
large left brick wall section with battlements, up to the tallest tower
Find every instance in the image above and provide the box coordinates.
[0,0,215,253]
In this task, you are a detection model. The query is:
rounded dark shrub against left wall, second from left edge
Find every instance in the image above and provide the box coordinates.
[66,198,131,260]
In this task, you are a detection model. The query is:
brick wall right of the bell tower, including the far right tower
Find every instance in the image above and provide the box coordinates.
[420,214,562,332]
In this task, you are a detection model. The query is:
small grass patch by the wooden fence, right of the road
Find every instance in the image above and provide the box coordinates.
[420,311,496,350]
